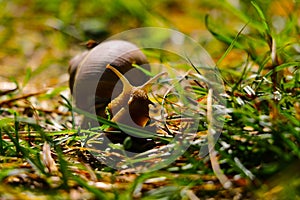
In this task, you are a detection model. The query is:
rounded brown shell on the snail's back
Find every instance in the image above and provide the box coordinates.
[69,40,150,120]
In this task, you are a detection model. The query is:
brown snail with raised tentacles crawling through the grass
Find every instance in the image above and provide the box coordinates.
[69,40,165,130]
